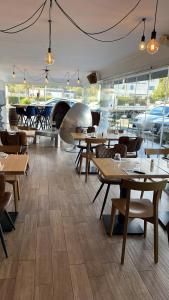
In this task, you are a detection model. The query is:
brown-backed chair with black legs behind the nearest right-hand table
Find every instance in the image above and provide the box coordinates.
[93,144,127,219]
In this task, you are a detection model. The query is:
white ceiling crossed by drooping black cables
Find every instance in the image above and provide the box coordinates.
[0,0,169,82]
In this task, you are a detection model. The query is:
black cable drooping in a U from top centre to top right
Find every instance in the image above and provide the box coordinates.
[55,0,142,35]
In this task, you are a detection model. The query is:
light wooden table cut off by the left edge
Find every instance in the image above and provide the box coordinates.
[0,154,29,231]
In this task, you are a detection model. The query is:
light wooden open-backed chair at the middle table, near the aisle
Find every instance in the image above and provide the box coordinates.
[79,138,106,182]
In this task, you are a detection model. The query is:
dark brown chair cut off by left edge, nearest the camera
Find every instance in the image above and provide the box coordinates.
[0,174,15,257]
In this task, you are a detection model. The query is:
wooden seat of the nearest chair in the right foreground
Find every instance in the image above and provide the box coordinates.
[112,198,153,218]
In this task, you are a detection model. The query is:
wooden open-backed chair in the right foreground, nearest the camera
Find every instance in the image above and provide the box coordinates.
[110,180,167,264]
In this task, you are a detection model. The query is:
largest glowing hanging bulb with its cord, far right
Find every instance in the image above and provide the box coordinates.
[147,0,160,54]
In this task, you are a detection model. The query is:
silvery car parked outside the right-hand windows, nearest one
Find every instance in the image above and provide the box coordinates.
[133,105,169,131]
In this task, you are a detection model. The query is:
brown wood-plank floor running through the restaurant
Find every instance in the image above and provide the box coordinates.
[0,144,169,300]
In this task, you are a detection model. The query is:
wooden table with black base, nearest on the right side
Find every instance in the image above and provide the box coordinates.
[92,158,169,234]
